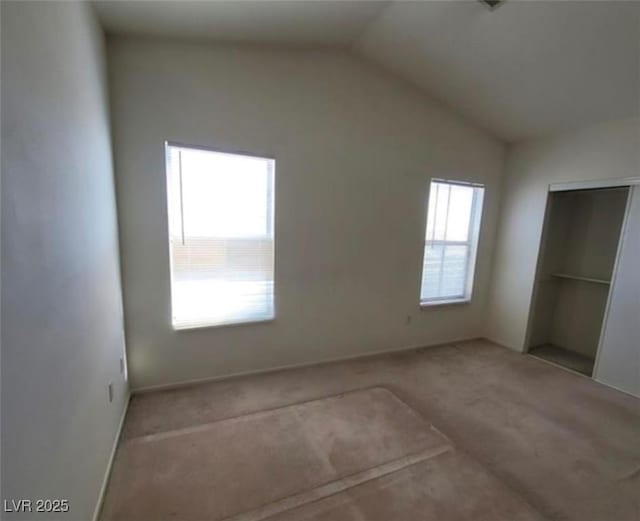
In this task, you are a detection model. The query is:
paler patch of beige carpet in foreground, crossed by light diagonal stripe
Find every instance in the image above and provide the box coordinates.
[104,387,540,521]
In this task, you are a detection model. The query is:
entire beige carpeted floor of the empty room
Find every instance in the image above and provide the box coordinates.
[102,341,640,521]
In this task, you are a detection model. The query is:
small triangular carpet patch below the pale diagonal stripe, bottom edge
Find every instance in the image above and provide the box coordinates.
[272,451,544,521]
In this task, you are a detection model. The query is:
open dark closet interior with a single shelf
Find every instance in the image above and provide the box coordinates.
[526,186,629,376]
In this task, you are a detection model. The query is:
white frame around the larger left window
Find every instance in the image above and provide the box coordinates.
[164,140,278,333]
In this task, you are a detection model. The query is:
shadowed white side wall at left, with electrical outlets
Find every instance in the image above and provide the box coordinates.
[2,1,126,520]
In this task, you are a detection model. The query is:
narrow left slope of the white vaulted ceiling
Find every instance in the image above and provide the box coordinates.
[93,0,389,47]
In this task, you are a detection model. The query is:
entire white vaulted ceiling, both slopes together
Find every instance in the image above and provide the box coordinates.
[94,0,640,141]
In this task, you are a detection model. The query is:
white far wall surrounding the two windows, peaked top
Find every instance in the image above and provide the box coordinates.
[108,39,503,388]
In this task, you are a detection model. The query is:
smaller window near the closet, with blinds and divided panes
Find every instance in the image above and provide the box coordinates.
[420,180,484,305]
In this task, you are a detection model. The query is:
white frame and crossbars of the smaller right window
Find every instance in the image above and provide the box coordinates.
[419,178,486,308]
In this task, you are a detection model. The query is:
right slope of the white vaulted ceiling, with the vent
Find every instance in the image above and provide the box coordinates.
[357,0,640,141]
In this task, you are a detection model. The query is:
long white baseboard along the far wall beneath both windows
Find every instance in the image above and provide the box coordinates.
[131,336,482,394]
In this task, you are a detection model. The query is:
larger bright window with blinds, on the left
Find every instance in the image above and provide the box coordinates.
[166,144,275,329]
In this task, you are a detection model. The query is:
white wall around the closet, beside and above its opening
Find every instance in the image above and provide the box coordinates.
[485,118,640,350]
